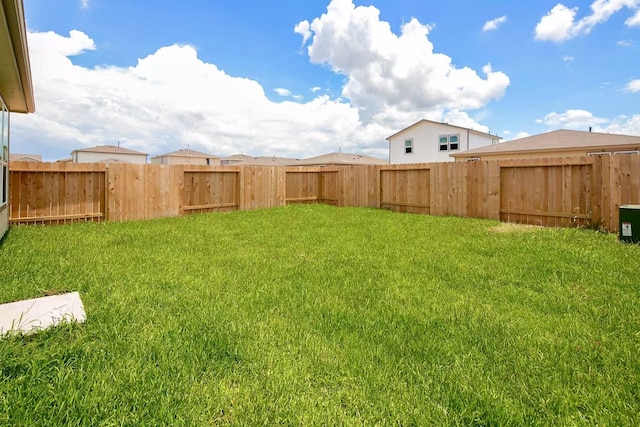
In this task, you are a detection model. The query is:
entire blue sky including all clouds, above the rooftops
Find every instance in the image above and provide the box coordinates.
[12,0,640,160]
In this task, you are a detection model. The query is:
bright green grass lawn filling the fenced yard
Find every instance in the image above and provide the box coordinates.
[0,205,640,426]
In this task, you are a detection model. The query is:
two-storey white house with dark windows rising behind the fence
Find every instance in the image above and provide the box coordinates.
[387,120,502,164]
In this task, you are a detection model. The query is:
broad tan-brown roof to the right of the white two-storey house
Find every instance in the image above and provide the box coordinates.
[451,129,640,157]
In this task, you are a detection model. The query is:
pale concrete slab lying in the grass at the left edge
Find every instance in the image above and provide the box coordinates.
[0,292,86,337]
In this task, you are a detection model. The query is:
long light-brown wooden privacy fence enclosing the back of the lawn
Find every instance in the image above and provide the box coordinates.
[10,154,640,231]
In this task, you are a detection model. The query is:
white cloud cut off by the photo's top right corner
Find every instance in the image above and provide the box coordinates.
[535,0,640,42]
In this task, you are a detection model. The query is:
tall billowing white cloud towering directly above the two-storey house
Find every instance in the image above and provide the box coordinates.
[294,0,509,122]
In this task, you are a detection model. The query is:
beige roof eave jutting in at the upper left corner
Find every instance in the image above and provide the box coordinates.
[0,0,35,113]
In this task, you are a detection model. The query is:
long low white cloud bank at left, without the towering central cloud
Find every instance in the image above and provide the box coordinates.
[12,31,397,159]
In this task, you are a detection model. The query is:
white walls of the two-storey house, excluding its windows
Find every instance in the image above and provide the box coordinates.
[389,122,497,164]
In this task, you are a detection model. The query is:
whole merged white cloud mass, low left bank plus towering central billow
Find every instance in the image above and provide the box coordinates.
[12,0,500,159]
